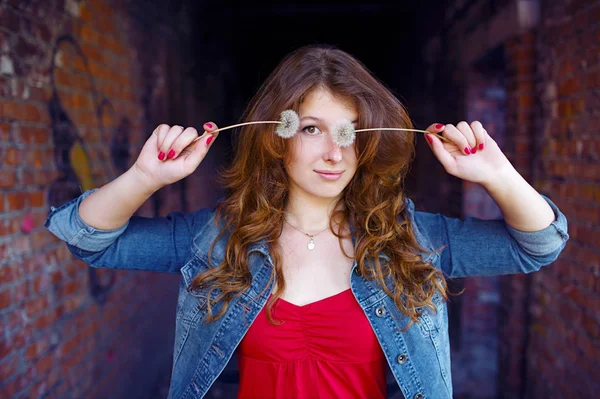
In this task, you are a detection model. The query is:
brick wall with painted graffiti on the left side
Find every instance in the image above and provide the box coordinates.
[0,0,221,398]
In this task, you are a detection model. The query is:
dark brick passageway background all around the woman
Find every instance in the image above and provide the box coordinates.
[0,0,600,399]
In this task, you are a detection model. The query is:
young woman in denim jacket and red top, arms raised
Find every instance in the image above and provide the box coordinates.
[46,46,568,399]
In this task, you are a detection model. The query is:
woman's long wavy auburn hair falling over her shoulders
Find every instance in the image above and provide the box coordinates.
[190,45,447,329]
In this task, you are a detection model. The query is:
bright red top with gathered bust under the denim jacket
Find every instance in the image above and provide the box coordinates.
[238,289,386,399]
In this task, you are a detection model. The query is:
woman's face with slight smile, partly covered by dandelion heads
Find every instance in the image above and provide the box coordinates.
[286,88,358,203]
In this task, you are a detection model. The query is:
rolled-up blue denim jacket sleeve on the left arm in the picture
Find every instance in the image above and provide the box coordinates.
[44,189,212,273]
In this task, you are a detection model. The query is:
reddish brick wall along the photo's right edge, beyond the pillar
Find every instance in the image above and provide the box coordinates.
[507,0,600,398]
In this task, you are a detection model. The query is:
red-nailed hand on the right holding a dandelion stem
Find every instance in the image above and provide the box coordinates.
[425,121,512,185]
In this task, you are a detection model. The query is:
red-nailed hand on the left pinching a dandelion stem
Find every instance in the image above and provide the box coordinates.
[132,122,218,191]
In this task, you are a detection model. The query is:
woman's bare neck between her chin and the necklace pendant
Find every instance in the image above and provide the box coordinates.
[285,192,339,234]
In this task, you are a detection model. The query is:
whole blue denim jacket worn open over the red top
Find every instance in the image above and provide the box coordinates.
[45,190,569,399]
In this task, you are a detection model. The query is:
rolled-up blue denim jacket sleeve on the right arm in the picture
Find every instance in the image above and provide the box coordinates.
[409,195,569,278]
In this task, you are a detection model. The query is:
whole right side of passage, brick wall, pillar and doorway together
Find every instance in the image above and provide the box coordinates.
[424,0,600,399]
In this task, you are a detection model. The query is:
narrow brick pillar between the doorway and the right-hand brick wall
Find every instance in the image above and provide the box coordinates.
[498,32,550,397]
